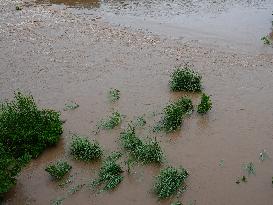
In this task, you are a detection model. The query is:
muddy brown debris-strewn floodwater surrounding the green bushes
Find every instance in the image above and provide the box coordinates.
[0,0,273,205]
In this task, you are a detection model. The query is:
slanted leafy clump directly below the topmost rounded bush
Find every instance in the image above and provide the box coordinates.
[160,97,193,132]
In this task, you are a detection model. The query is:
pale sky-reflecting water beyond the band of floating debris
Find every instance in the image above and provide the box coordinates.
[37,0,273,53]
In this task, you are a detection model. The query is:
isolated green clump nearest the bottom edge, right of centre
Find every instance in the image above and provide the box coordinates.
[154,167,189,199]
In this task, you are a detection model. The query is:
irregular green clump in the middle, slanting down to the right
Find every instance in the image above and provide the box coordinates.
[120,126,163,164]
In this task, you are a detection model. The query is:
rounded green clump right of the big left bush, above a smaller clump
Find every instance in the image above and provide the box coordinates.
[70,137,102,162]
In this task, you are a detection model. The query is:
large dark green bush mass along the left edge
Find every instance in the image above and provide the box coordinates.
[0,92,62,195]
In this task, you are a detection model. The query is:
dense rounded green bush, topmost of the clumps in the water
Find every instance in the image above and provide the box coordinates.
[169,64,202,92]
